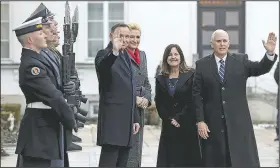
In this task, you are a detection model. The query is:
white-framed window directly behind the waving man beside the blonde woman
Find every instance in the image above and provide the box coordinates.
[88,1,124,58]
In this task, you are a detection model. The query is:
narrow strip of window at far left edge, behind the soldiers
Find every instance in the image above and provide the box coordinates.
[1,2,10,59]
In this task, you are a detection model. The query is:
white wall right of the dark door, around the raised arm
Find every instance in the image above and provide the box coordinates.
[246,1,279,93]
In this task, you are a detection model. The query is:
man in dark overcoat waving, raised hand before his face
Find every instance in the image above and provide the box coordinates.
[95,24,140,167]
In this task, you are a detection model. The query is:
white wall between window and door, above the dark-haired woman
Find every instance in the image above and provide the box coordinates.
[127,1,197,77]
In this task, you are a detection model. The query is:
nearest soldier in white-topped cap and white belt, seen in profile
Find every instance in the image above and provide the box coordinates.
[14,17,76,167]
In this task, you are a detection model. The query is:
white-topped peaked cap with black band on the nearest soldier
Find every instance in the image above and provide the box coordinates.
[13,17,43,36]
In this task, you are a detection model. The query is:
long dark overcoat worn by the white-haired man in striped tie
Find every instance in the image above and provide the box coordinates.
[193,53,277,167]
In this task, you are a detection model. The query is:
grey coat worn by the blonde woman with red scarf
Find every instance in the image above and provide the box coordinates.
[127,50,151,167]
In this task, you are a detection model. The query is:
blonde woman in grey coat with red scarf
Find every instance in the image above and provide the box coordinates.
[127,24,151,167]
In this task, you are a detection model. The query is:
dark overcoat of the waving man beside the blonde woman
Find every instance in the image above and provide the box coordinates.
[95,44,139,147]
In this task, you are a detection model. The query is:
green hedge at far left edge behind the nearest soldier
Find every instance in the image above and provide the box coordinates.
[1,104,21,121]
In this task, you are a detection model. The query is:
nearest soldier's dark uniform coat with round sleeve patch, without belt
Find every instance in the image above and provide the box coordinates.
[16,48,75,160]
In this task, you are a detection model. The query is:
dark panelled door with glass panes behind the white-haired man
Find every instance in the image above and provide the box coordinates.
[197,0,245,58]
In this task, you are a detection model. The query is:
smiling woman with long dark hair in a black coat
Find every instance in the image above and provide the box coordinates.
[155,44,201,167]
